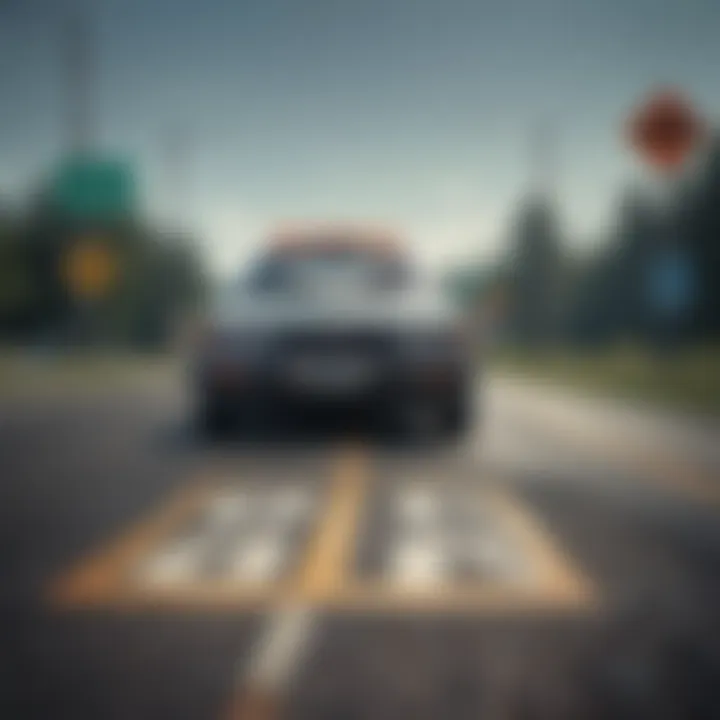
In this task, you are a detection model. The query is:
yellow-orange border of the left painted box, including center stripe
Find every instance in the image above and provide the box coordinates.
[49,448,366,611]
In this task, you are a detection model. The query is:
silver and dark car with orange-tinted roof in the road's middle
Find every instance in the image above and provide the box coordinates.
[191,227,474,438]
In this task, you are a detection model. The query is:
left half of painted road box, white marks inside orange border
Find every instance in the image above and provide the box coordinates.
[51,479,320,607]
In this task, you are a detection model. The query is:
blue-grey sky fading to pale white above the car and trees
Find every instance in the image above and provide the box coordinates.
[0,0,720,275]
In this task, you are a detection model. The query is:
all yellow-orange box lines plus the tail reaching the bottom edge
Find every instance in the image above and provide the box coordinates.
[51,445,598,720]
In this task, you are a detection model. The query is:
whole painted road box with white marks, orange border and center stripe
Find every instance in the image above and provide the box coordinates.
[47,451,595,612]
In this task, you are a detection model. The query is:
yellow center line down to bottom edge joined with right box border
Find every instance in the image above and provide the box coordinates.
[221,462,597,720]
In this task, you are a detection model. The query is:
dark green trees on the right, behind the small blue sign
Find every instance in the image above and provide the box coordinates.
[458,129,720,349]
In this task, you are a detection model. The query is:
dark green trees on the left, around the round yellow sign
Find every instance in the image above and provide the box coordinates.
[0,205,206,346]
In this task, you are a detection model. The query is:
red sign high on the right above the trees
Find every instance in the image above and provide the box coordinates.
[629,90,704,171]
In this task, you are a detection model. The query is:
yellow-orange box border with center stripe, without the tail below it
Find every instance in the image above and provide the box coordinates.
[50,448,598,614]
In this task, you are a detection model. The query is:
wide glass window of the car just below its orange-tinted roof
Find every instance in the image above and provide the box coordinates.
[250,247,410,292]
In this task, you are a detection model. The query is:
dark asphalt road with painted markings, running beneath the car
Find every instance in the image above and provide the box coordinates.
[0,378,720,720]
